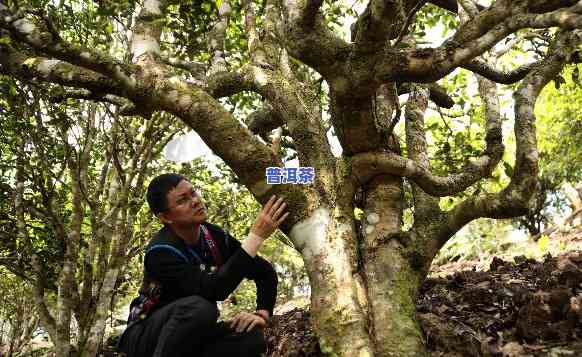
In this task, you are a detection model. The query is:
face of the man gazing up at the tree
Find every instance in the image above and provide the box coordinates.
[159,180,208,226]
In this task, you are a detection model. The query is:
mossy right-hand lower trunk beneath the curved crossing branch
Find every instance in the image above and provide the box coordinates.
[362,175,425,357]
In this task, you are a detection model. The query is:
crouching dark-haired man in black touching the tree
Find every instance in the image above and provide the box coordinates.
[118,174,289,357]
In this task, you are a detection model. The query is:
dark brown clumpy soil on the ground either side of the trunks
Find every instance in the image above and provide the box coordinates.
[267,230,582,357]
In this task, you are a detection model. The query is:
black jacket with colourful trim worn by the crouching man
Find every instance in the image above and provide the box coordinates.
[130,222,277,315]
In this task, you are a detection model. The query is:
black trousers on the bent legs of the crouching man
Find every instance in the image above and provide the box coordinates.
[119,296,267,357]
